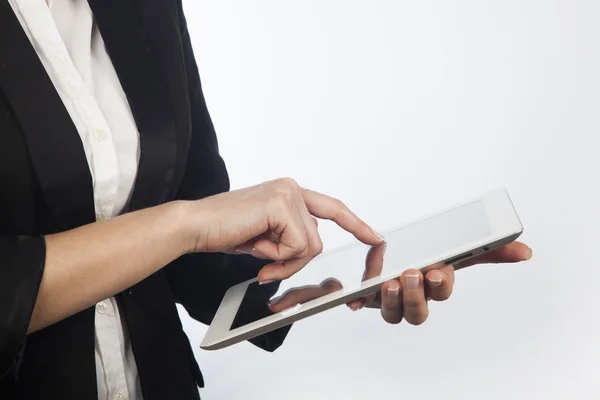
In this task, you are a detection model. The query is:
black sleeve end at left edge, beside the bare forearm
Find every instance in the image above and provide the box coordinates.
[0,236,46,387]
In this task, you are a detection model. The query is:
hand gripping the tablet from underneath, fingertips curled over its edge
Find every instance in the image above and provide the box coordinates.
[348,242,532,325]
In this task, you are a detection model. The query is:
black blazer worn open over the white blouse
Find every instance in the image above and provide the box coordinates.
[0,0,288,400]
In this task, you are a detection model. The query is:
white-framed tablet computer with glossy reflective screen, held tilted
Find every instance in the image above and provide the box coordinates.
[201,190,523,350]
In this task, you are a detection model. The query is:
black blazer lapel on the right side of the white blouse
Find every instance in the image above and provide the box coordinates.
[88,0,178,211]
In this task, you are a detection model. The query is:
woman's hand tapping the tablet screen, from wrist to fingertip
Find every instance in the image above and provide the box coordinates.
[187,178,383,282]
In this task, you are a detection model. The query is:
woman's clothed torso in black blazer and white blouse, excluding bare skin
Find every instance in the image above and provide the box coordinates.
[0,0,287,400]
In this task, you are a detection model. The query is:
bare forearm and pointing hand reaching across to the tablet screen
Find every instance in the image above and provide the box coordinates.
[22,179,382,333]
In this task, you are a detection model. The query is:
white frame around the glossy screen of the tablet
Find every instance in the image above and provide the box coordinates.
[200,190,523,350]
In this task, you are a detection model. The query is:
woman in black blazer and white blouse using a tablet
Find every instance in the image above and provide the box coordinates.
[0,0,531,400]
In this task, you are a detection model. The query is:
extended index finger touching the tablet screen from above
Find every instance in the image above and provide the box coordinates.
[302,188,384,246]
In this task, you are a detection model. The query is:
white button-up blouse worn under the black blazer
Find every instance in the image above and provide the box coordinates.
[9,0,142,400]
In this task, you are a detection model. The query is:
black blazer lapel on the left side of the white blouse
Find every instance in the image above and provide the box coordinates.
[0,0,95,231]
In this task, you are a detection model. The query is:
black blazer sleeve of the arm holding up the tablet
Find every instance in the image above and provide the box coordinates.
[165,0,290,351]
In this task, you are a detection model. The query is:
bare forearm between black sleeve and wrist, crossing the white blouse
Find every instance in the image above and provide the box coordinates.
[28,202,189,333]
